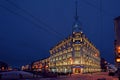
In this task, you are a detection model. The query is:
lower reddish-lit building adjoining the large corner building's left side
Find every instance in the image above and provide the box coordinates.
[32,58,49,72]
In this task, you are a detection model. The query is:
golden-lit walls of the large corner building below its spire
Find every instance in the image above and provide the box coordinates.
[49,32,100,73]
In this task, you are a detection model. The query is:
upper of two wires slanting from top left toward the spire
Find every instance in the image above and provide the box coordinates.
[5,0,64,38]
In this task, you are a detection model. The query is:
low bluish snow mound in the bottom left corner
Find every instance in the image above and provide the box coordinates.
[0,71,33,79]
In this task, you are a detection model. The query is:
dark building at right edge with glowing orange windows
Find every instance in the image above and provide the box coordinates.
[114,16,120,67]
